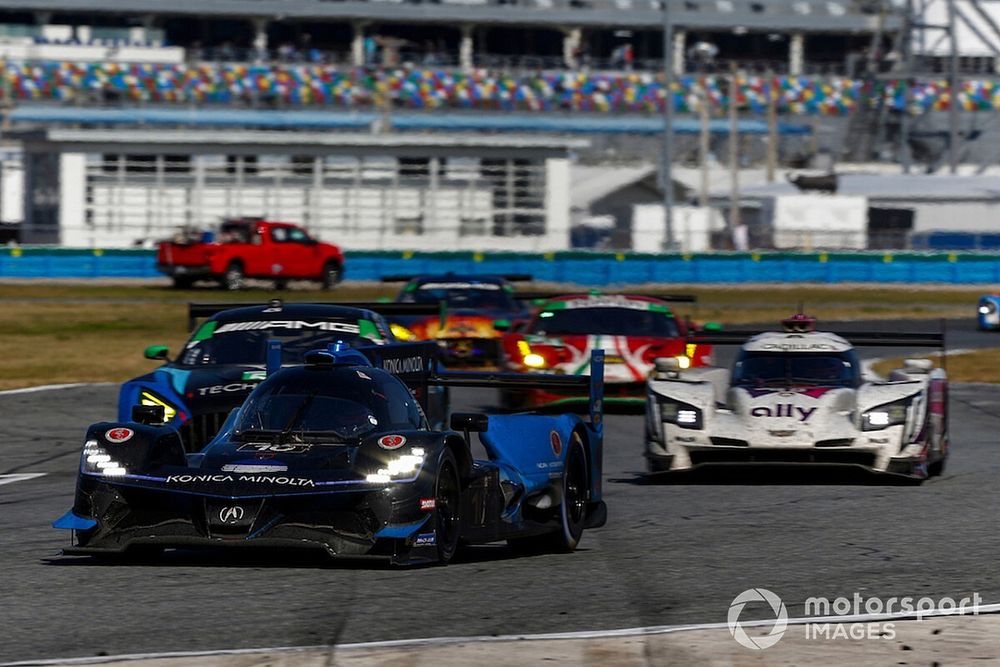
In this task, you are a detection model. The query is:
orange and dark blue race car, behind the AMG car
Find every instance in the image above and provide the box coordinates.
[382,273,531,368]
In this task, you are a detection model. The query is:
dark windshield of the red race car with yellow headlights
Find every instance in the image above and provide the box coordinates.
[528,308,680,338]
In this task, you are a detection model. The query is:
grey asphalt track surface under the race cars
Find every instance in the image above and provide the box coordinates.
[0,323,1000,662]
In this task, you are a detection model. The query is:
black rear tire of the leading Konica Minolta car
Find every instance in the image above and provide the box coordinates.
[507,433,589,553]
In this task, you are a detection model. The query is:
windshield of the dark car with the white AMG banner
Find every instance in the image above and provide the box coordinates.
[177,323,372,366]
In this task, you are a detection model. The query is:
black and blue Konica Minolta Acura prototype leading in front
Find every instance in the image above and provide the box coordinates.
[53,343,607,564]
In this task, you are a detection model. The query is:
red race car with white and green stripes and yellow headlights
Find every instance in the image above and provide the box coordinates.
[501,292,712,409]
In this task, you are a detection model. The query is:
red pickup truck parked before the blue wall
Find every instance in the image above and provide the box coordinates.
[156,219,344,290]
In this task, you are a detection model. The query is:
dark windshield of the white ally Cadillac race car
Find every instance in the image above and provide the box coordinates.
[733,352,859,387]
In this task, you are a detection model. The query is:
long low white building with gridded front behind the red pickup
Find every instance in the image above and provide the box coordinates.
[16,128,587,251]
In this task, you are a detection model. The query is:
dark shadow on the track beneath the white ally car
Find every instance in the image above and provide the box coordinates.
[608,464,922,486]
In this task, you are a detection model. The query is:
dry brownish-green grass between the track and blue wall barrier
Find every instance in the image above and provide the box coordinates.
[0,282,980,389]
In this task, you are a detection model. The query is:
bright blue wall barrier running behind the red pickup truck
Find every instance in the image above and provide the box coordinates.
[0,246,1000,286]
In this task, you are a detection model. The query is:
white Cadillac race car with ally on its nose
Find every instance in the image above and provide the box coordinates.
[646,315,948,479]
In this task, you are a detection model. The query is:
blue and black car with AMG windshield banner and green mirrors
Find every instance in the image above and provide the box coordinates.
[118,299,438,451]
